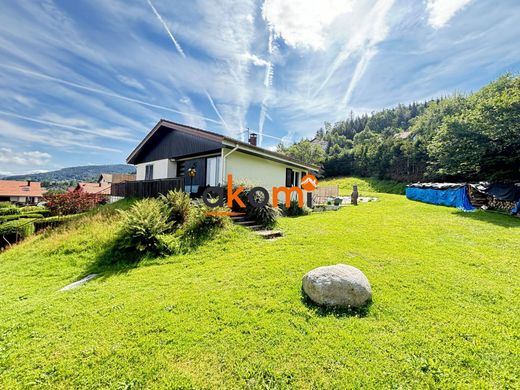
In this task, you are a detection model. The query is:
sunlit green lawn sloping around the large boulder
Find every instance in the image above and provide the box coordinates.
[0,180,520,389]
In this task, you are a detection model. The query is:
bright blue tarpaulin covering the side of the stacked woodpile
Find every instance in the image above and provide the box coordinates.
[406,185,475,211]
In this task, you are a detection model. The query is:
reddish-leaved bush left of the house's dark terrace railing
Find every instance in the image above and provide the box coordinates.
[45,192,106,215]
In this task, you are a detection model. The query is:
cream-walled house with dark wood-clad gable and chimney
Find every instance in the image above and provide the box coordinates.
[126,119,319,198]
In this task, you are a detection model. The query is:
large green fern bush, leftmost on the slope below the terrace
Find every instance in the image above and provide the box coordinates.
[118,199,173,255]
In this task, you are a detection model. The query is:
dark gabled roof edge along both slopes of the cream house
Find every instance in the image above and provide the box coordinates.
[126,119,319,171]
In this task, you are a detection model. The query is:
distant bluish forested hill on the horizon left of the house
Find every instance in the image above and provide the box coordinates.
[4,164,135,182]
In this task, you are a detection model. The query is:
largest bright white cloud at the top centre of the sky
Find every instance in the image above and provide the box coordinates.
[262,0,352,50]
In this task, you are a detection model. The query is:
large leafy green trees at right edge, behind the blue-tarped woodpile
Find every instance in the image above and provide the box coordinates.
[428,75,520,181]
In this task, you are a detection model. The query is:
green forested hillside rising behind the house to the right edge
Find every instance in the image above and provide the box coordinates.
[278,74,520,182]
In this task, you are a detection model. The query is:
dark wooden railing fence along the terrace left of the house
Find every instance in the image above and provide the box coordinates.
[110,177,184,198]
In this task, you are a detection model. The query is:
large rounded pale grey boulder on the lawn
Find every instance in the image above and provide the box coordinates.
[302,264,372,308]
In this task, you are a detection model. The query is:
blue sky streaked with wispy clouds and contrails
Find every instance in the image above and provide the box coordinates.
[0,0,520,175]
